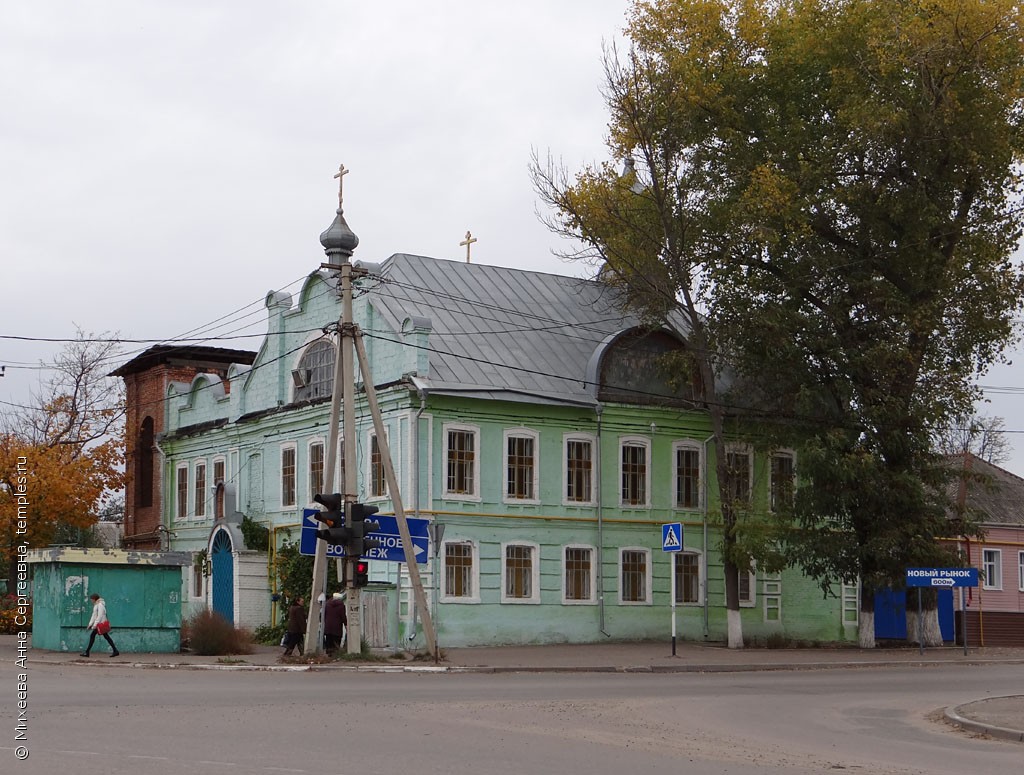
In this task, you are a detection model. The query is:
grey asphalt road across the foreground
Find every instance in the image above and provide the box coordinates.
[0,664,1024,775]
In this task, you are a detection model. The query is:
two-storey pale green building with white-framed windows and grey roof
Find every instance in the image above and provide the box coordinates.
[119,200,857,647]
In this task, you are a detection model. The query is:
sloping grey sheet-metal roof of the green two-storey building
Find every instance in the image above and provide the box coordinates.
[368,254,679,405]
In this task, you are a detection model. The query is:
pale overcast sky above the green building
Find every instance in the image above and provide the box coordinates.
[0,0,1024,476]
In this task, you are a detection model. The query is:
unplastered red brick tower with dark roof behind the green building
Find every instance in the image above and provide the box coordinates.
[111,345,256,551]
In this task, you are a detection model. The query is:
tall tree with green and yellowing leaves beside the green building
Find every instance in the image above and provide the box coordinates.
[535,0,1024,645]
